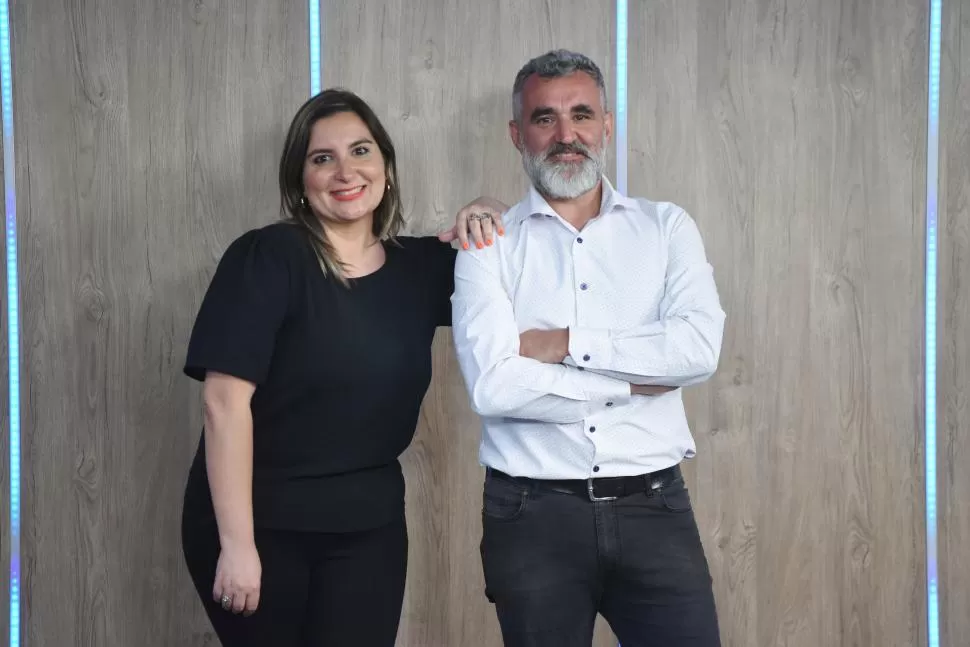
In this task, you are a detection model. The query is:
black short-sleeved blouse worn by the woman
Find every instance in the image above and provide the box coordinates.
[184,223,456,532]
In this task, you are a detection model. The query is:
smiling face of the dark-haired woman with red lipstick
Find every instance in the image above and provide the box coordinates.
[303,112,387,226]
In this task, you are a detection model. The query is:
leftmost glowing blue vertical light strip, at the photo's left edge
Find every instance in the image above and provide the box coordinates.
[0,0,21,647]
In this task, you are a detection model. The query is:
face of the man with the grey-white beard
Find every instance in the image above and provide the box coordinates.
[509,72,613,200]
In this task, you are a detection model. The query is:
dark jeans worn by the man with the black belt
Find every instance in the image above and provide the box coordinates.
[481,469,720,647]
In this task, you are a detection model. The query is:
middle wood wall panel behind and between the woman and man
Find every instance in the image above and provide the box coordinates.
[323,0,615,647]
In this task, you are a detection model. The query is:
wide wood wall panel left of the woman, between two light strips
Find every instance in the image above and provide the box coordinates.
[13,0,307,647]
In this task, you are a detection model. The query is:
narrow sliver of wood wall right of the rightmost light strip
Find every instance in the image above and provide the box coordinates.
[937,2,970,645]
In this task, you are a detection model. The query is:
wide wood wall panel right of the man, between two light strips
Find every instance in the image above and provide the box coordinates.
[629,0,928,647]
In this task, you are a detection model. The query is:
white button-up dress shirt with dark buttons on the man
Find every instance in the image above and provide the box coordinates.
[452,178,725,479]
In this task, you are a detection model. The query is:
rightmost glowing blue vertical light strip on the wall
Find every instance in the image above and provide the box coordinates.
[924,0,943,647]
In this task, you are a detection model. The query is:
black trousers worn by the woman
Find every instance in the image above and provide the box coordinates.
[182,515,408,647]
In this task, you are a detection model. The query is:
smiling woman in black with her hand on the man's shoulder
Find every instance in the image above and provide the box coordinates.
[182,90,503,647]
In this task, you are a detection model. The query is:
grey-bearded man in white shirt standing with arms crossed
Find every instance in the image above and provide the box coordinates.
[452,50,724,647]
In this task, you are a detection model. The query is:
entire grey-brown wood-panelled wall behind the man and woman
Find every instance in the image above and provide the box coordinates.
[0,0,956,647]
